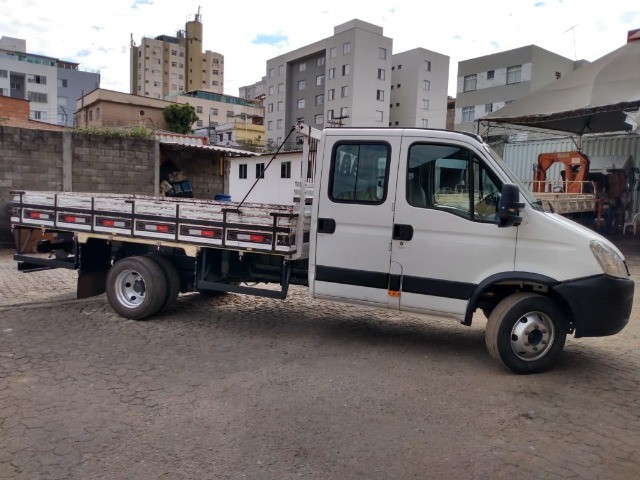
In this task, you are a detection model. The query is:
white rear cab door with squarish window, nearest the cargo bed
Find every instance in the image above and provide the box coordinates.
[309,130,401,307]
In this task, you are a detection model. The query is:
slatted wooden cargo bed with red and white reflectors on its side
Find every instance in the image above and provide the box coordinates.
[11,191,311,259]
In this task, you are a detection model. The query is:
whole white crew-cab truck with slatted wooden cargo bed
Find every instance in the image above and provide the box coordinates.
[12,124,634,373]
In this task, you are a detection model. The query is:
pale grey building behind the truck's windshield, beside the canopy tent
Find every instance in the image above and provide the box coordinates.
[455,45,584,132]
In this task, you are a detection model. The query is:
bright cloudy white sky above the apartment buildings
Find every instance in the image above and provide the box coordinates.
[0,0,640,97]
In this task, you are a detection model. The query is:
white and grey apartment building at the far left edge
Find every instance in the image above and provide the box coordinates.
[0,37,100,127]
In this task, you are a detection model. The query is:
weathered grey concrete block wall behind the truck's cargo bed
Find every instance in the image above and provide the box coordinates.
[0,126,158,245]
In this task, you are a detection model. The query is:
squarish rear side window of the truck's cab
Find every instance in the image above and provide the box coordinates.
[329,143,391,205]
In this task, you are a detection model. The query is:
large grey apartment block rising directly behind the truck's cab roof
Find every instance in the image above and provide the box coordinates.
[264,20,393,148]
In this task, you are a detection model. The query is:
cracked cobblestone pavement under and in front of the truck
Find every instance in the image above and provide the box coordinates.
[0,235,640,479]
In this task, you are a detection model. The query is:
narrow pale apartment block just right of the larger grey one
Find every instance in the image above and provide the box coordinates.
[389,48,449,129]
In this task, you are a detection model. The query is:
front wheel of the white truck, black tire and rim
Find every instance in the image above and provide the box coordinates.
[484,292,567,374]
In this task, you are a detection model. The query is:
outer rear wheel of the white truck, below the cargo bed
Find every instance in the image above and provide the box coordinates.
[107,256,167,320]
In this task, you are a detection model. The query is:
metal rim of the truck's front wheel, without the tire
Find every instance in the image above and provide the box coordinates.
[511,312,555,362]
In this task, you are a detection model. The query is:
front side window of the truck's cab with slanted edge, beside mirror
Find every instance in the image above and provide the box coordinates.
[406,144,500,221]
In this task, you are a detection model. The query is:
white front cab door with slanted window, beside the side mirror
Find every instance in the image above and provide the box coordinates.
[391,132,517,317]
